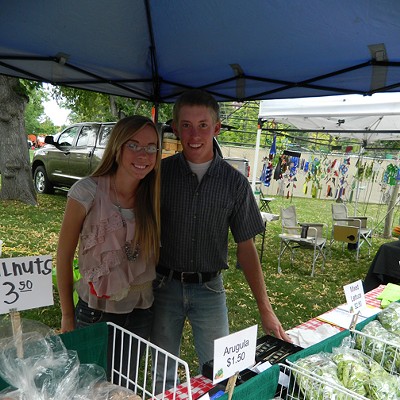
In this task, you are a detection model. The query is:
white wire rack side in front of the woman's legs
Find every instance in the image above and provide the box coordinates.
[107,322,192,400]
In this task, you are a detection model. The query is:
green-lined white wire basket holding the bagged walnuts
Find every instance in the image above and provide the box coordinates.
[0,323,192,400]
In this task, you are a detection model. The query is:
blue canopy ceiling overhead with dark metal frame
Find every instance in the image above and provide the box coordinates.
[0,0,400,102]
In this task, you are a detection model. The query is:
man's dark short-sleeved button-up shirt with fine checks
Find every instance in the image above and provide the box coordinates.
[159,153,265,272]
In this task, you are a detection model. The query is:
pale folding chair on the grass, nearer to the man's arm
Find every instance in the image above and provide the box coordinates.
[278,206,327,276]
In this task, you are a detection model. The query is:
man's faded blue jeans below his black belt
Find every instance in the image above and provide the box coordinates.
[150,274,229,392]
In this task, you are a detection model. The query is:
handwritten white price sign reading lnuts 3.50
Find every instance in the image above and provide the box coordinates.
[0,256,54,314]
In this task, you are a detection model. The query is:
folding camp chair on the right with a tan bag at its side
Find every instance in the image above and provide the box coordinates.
[330,203,372,260]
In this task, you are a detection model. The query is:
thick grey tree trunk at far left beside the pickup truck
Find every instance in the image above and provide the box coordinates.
[0,75,37,205]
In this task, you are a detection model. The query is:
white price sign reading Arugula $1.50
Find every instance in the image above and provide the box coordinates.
[213,325,257,385]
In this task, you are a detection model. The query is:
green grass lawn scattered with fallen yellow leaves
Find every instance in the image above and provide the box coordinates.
[0,192,398,373]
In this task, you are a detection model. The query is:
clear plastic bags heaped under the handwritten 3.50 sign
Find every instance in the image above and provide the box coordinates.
[0,318,140,400]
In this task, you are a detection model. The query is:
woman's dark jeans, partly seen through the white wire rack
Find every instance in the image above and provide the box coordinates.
[75,299,153,386]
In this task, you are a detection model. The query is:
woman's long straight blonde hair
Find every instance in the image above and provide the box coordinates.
[92,115,161,262]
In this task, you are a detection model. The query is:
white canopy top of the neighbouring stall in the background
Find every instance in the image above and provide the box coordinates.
[259,93,400,143]
